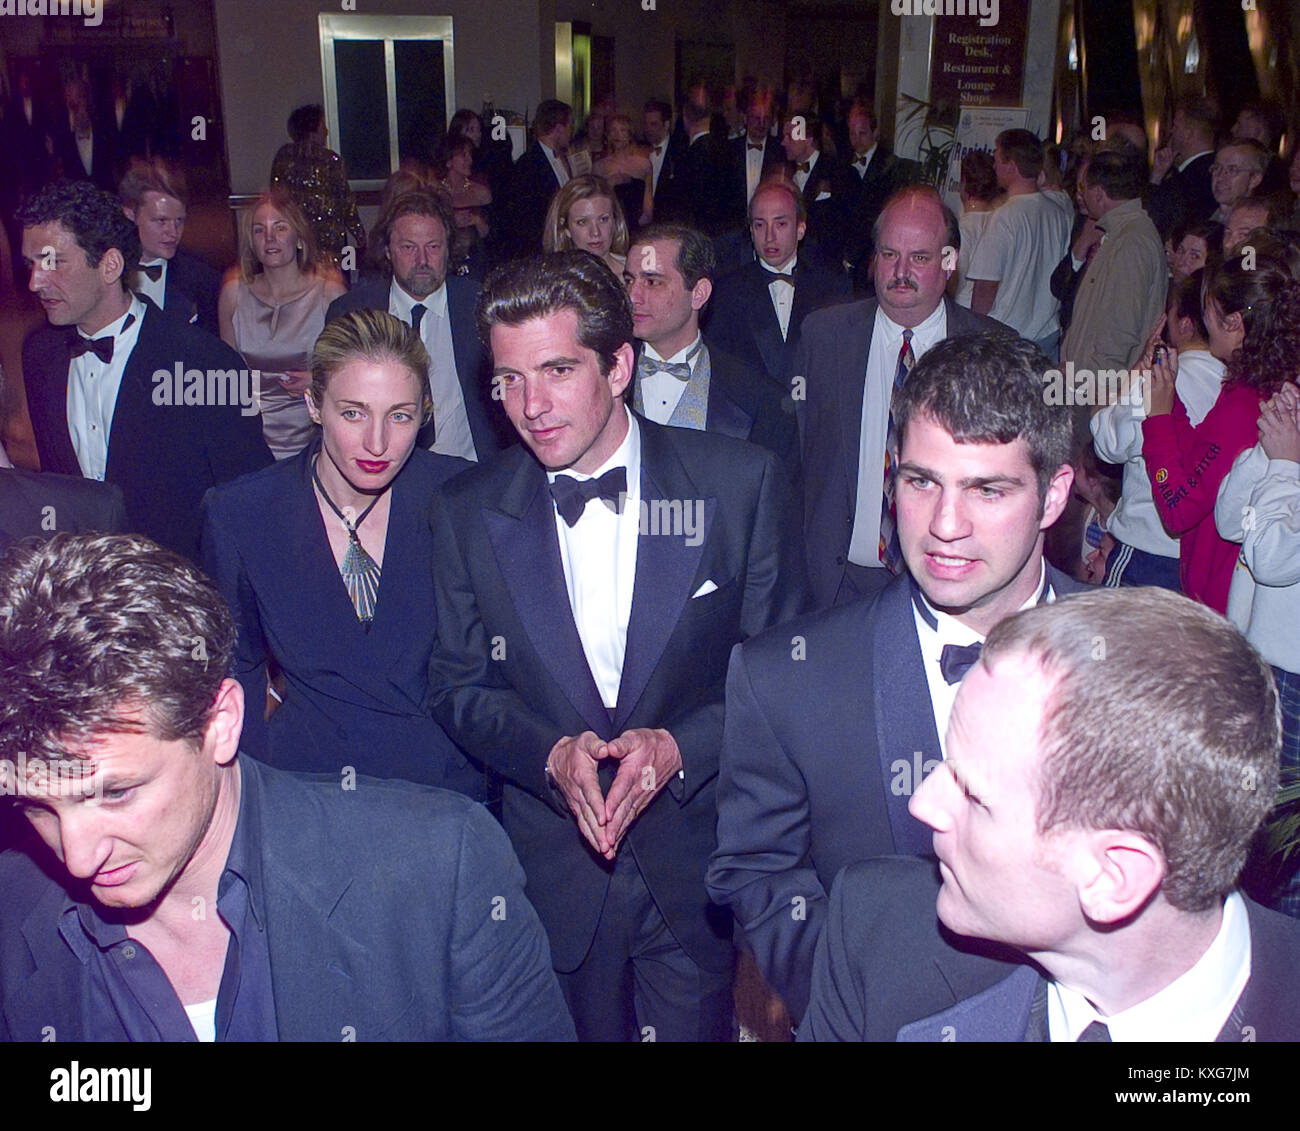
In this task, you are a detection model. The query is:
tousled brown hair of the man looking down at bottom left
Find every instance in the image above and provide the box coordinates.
[0,534,239,762]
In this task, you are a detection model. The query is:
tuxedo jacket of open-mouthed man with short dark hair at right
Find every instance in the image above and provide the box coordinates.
[707,567,1083,1018]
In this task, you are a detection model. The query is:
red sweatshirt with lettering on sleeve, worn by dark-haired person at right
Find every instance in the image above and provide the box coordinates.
[1141,385,1264,614]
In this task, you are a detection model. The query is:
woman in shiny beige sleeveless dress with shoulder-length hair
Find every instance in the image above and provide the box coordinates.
[217,187,345,459]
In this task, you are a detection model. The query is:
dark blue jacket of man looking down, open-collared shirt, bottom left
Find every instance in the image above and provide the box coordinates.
[0,758,573,1041]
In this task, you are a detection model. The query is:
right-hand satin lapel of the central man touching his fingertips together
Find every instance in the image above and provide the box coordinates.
[613,425,718,733]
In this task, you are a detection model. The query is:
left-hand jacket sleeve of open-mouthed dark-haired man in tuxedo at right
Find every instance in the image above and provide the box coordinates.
[707,641,827,1019]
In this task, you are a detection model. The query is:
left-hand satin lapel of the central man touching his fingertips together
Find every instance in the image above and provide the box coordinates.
[482,455,613,737]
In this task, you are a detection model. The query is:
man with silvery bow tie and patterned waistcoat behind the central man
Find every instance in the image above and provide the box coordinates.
[623,224,800,482]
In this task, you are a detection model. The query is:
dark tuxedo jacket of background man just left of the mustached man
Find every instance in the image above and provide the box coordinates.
[705,256,852,391]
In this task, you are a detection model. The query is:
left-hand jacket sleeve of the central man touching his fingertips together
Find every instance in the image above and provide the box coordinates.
[429,491,568,815]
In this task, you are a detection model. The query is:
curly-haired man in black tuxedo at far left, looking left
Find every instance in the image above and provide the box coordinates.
[18,181,272,558]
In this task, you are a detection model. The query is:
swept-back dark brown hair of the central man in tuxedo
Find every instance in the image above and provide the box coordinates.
[478,251,632,374]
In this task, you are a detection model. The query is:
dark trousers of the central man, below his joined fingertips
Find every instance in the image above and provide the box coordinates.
[558,841,733,1041]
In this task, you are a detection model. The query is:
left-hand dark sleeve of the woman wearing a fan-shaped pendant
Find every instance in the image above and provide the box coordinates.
[199,490,270,762]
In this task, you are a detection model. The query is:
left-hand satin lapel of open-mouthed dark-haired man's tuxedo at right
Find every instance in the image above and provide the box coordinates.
[872,579,943,855]
